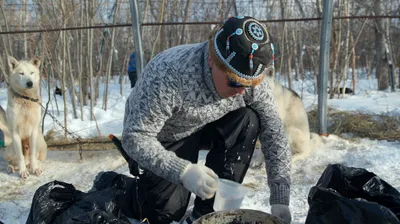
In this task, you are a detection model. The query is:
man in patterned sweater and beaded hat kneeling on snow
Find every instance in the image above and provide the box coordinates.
[95,16,291,224]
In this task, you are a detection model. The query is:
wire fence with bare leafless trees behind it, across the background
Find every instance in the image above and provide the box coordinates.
[0,0,400,145]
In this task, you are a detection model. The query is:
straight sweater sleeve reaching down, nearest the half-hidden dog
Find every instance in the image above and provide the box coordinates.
[250,80,292,205]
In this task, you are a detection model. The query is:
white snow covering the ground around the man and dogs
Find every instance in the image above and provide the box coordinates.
[0,74,400,224]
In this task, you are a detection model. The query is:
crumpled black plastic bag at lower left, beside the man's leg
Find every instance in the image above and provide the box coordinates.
[26,178,129,224]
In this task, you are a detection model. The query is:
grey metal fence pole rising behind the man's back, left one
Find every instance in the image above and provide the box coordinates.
[130,0,143,78]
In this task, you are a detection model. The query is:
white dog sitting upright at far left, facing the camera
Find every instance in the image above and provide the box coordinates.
[6,57,42,179]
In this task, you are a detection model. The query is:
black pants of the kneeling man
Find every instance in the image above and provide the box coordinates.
[95,107,260,224]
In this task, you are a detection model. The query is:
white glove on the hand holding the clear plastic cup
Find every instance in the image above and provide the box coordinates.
[180,164,218,200]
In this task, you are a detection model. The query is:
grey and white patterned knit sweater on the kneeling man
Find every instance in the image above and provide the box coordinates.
[122,42,291,205]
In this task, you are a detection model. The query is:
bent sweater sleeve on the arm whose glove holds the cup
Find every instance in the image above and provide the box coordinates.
[122,62,190,184]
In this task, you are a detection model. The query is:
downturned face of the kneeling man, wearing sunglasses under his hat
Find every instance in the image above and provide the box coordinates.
[208,56,246,98]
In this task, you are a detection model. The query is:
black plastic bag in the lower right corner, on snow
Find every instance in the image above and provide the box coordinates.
[306,164,400,224]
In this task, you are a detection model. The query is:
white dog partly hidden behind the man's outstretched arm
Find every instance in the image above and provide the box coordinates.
[250,77,322,167]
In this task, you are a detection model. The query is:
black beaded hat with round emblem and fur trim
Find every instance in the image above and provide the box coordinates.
[209,16,274,86]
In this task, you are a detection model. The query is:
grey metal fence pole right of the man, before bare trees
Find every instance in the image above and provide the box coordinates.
[318,0,333,135]
